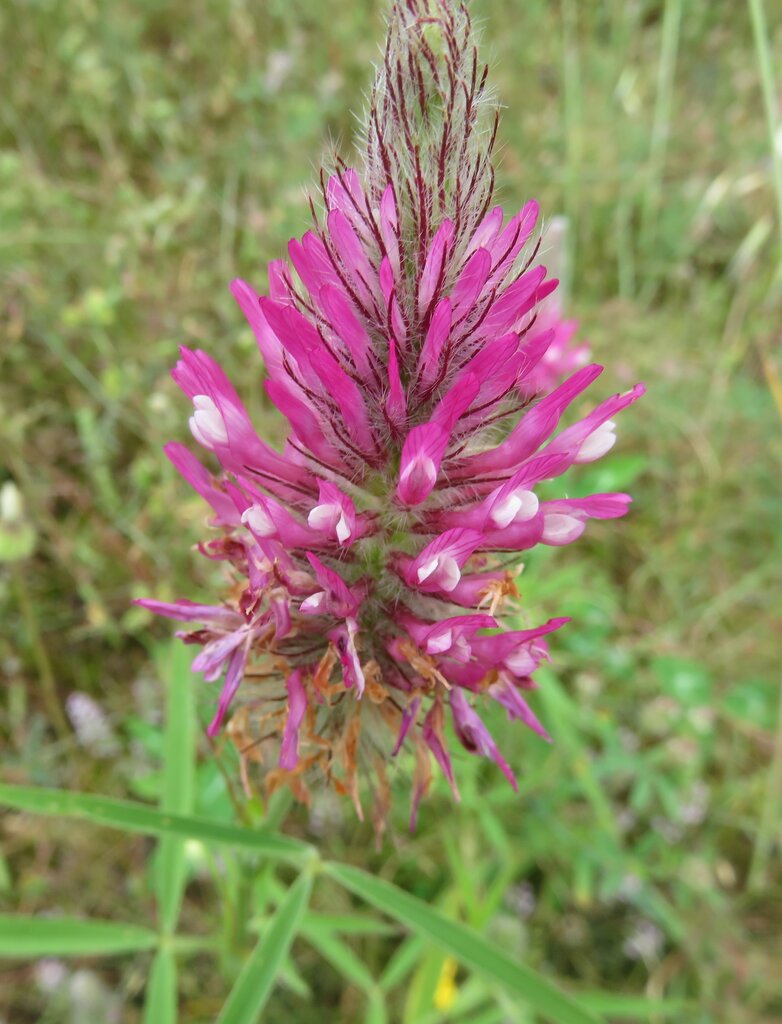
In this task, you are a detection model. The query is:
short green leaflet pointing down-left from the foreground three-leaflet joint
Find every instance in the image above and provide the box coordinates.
[218,870,312,1024]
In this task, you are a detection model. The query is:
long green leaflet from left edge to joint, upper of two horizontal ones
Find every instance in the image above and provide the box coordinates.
[0,783,314,864]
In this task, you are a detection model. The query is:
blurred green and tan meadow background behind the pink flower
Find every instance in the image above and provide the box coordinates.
[0,0,782,1024]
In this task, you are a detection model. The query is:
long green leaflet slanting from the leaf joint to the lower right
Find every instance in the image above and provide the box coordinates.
[324,863,598,1024]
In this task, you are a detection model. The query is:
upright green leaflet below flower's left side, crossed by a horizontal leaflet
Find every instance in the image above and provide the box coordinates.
[156,643,196,935]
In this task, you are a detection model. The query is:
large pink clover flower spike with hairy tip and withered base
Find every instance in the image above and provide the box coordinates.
[139,0,643,827]
